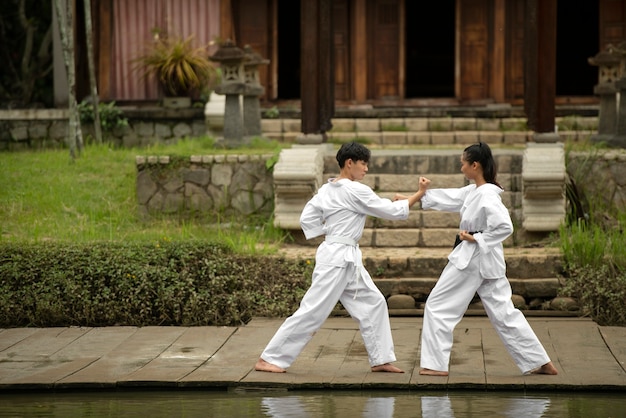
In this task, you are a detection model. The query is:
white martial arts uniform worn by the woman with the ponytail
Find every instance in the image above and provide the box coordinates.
[421,183,550,374]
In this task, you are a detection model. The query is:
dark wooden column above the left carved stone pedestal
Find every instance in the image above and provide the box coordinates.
[297,0,335,143]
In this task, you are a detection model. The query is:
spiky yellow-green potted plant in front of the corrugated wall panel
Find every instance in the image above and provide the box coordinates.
[133,32,219,107]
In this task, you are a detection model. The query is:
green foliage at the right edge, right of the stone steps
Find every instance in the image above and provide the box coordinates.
[559,148,626,325]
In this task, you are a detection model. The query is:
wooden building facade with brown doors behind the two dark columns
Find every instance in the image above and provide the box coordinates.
[86,0,626,106]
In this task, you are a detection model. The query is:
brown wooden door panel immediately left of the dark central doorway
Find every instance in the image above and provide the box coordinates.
[364,0,403,99]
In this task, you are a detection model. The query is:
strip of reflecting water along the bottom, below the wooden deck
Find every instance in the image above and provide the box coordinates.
[0,390,626,418]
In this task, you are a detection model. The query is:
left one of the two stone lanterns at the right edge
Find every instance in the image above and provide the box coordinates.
[588,45,621,142]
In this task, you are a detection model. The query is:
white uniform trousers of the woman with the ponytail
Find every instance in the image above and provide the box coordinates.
[420,257,550,374]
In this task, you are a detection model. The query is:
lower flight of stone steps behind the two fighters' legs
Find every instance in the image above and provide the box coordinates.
[279,241,578,316]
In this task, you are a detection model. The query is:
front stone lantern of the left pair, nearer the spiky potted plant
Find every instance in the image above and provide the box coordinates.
[209,39,245,147]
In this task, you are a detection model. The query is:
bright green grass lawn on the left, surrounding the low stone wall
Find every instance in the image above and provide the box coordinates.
[0,138,285,252]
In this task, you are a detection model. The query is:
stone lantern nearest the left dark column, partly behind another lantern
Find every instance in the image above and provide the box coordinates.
[243,45,270,136]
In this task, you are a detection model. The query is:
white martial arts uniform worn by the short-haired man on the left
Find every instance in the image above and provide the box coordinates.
[261,179,409,368]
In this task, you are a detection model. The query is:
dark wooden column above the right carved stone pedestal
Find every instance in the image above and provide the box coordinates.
[524,0,557,134]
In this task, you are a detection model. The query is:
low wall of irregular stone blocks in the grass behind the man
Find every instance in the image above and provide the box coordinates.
[135,155,275,221]
